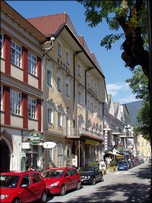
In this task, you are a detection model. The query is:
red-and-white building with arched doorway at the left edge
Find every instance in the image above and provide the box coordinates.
[0,1,46,171]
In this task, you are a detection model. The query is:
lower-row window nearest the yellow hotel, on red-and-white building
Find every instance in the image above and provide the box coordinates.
[28,97,37,119]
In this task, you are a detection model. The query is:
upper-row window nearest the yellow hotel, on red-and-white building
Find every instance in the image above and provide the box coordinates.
[28,53,37,76]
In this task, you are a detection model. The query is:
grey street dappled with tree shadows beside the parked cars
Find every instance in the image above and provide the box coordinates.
[48,162,151,203]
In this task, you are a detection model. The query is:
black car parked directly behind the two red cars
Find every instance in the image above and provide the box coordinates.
[79,166,104,185]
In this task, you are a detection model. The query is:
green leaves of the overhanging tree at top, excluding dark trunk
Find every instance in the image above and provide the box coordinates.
[77,0,147,49]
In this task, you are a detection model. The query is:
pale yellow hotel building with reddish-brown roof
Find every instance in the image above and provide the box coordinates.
[29,13,106,168]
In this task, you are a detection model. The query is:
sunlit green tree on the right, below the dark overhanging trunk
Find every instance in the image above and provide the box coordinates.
[126,67,151,141]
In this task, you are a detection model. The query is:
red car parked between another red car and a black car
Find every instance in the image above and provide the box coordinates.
[42,167,81,195]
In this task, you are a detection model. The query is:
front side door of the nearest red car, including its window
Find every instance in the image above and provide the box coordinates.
[19,174,34,202]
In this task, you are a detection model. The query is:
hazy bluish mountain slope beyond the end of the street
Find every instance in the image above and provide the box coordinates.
[126,100,143,126]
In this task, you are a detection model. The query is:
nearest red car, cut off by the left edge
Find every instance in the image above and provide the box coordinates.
[0,171,47,203]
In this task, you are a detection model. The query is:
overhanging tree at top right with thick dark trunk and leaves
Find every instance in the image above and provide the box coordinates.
[77,0,149,78]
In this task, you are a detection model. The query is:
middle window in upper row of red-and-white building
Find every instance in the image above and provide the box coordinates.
[11,41,22,68]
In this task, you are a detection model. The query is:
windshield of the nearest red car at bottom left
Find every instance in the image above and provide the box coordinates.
[0,175,20,188]
